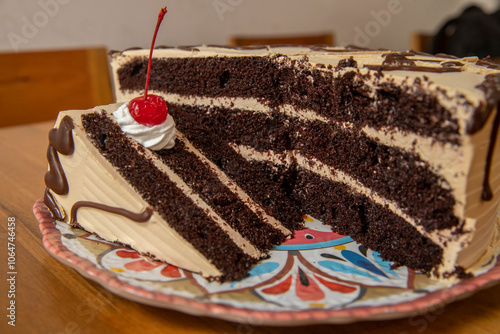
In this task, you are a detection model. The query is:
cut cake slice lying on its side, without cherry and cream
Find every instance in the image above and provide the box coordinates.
[45,105,298,279]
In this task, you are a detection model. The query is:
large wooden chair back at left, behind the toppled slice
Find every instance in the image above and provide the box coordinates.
[0,48,113,127]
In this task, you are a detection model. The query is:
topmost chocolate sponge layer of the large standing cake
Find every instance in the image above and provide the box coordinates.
[117,55,460,144]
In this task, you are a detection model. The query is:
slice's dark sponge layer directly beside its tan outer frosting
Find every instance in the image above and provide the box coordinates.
[82,113,257,280]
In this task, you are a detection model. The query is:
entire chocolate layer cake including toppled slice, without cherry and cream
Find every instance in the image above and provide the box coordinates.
[46,46,500,280]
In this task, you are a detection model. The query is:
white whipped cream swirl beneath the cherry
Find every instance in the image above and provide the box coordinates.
[113,102,175,151]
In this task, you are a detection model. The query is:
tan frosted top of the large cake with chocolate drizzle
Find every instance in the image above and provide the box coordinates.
[111,45,500,105]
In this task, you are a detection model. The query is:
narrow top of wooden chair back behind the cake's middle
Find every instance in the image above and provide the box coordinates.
[229,33,334,46]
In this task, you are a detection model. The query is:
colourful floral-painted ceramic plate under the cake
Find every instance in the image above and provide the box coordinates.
[33,199,500,326]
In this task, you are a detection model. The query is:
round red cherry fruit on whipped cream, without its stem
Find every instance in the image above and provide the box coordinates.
[128,94,168,126]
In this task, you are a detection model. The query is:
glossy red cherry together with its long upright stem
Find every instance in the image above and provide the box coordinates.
[129,7,168,127]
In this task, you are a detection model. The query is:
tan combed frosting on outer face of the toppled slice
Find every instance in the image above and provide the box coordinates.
[53,105,222,277]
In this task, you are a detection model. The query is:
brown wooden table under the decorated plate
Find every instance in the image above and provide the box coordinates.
[0,122,500,334]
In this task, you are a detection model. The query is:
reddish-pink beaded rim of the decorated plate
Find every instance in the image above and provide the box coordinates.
[33,198,500,326]
